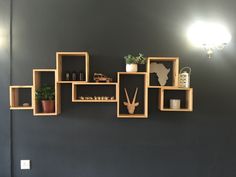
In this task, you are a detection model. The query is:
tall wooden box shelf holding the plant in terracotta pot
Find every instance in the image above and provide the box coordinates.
[32,69,61,116]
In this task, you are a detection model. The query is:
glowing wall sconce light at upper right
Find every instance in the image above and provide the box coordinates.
[187,22,231,58]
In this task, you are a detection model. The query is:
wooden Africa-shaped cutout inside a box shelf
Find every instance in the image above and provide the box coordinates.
[150,62,170,86]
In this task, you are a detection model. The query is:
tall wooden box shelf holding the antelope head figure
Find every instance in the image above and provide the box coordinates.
[117,72,148,118]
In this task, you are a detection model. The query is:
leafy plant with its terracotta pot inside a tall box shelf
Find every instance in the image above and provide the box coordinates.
[35,86,55,113]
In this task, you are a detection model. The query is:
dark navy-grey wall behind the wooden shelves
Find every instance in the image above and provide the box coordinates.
[0,0,236,177]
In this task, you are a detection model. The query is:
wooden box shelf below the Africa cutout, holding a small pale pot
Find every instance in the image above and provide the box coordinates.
[159,87,193,112]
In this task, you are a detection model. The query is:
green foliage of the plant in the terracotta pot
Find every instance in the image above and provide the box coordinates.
[35,86,55,100]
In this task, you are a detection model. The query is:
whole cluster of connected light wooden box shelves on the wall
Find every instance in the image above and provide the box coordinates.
[9,52,193,118]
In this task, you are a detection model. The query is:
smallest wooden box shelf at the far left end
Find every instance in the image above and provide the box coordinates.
[9,86,33,110]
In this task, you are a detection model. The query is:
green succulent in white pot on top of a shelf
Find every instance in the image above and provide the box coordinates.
[124,53,146,72]
